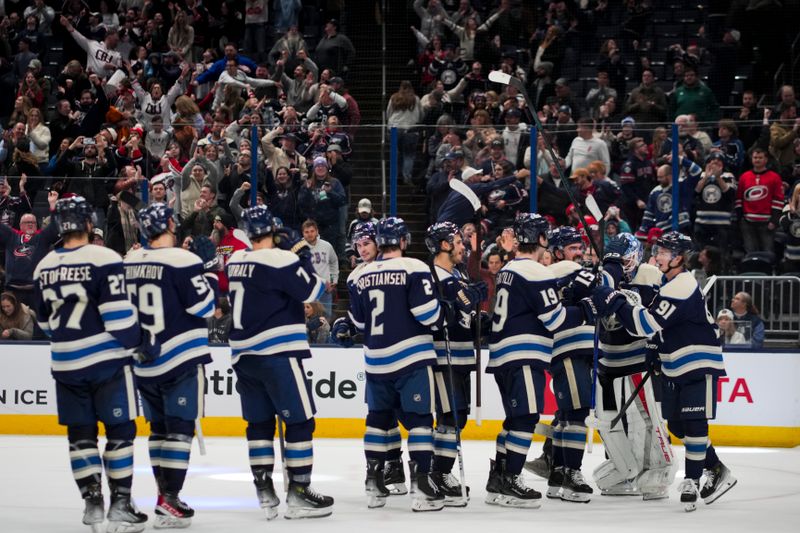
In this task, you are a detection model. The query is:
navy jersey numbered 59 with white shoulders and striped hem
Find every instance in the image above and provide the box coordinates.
[125,248,216,381]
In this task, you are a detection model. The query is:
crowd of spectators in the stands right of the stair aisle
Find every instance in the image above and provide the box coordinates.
[404,0,800,282]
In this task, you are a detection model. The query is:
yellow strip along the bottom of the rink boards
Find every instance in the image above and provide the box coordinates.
[0,415,800,448]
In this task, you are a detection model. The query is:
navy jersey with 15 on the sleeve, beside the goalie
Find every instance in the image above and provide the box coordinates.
[547,261,594,361]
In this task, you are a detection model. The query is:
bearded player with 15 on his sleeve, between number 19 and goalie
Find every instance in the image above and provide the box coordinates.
[547,226,595,502]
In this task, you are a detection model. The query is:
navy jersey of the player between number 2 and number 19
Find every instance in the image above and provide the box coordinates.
[433,266,475,369]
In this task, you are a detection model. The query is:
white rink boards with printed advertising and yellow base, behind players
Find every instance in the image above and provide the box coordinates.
[0,343,800,447]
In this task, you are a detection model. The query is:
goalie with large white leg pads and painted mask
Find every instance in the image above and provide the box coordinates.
[594,233,675,500]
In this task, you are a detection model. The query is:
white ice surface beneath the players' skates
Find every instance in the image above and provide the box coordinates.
[0,436,800,533]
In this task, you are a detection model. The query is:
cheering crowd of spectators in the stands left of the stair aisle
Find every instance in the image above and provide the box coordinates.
[0,0,372,341]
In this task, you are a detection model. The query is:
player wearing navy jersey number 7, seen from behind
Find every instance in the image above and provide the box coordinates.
[226,205,333,519]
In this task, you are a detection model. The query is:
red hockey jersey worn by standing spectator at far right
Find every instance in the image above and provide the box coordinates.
[734,170,784,224]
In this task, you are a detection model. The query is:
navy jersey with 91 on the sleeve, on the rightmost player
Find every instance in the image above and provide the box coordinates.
[617,272,725,380]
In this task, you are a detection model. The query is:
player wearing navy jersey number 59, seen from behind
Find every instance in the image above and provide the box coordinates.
[125,203,216,529]
